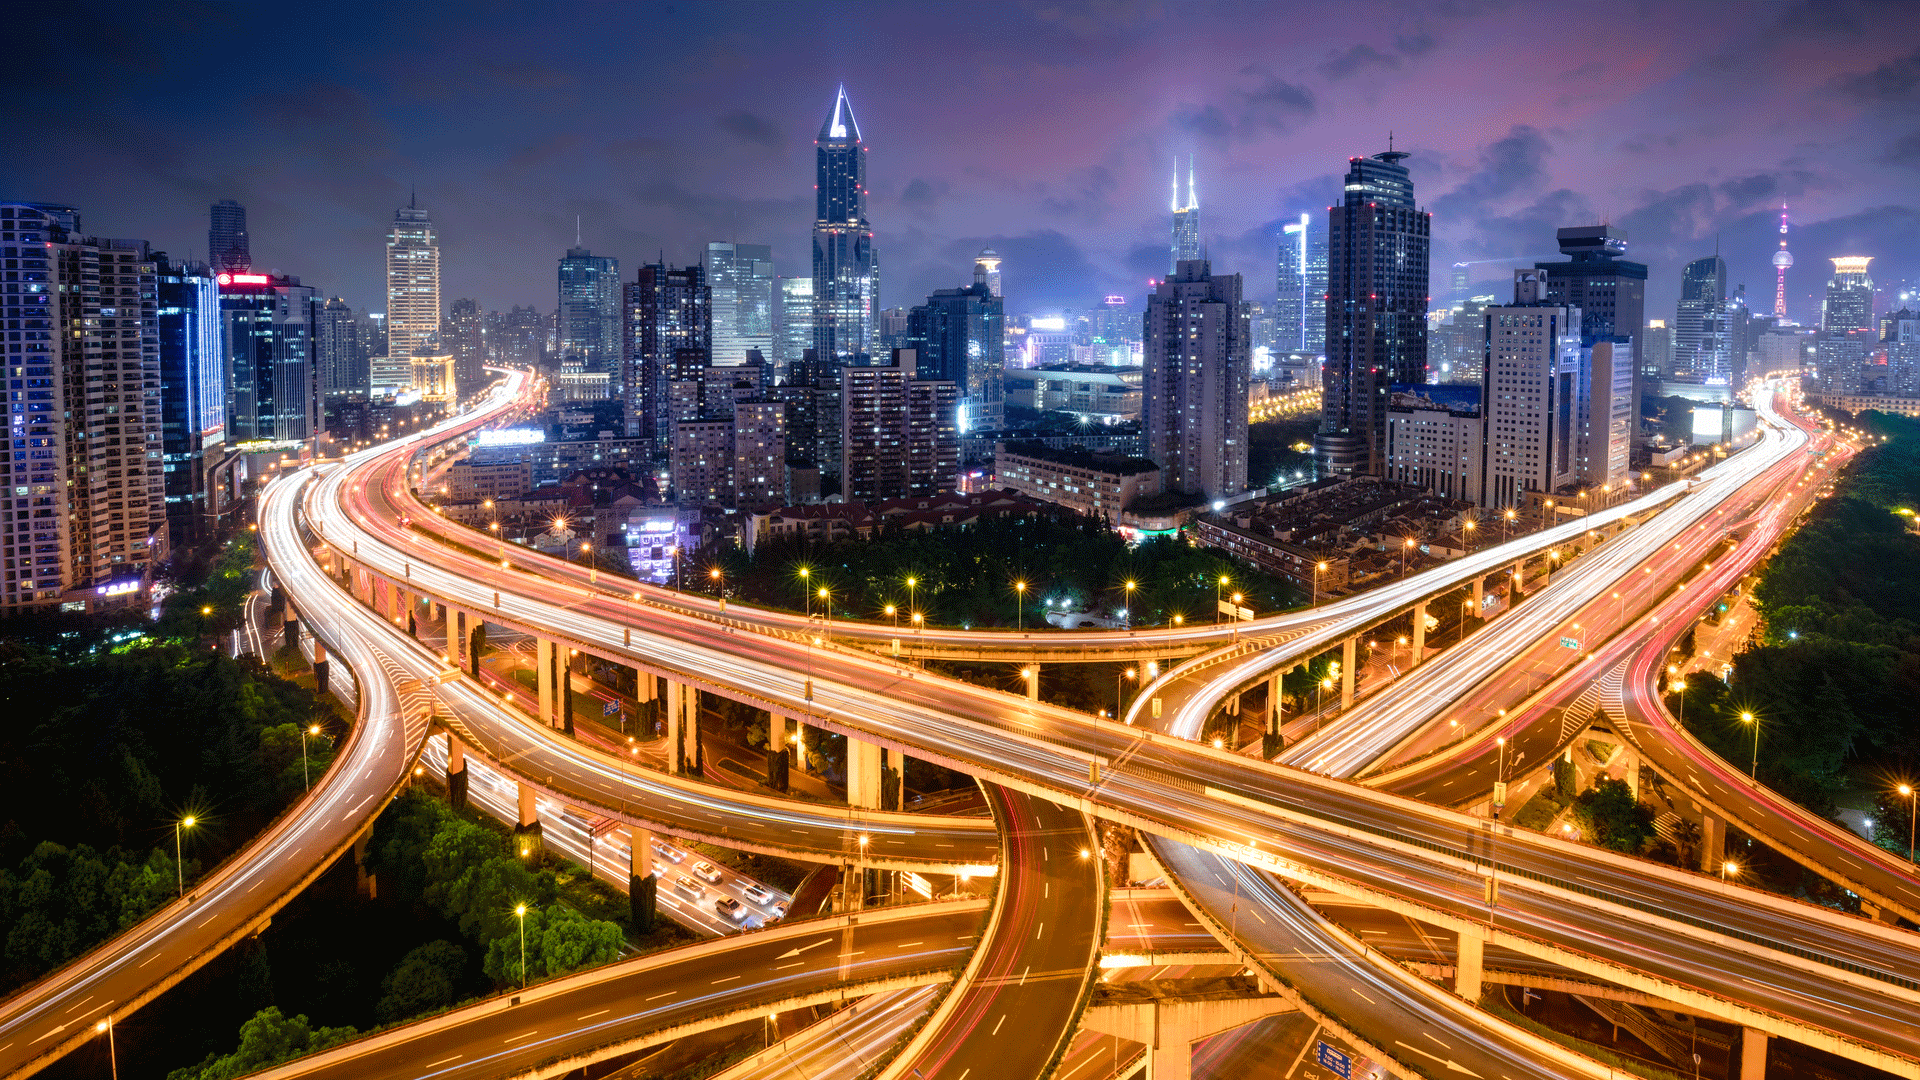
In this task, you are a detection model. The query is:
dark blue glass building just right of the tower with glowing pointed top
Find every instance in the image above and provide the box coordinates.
[906,281,1006,434]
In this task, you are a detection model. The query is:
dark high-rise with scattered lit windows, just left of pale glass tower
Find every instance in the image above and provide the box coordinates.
[620,263,712,441]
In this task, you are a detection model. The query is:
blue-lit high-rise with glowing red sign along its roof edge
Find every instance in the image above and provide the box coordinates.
[221,273,320,442]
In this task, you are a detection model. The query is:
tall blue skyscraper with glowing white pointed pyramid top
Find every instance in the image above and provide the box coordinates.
[814,86,879,367]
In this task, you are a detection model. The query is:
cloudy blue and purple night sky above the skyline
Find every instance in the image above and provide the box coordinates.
[0,0,1920,321]
